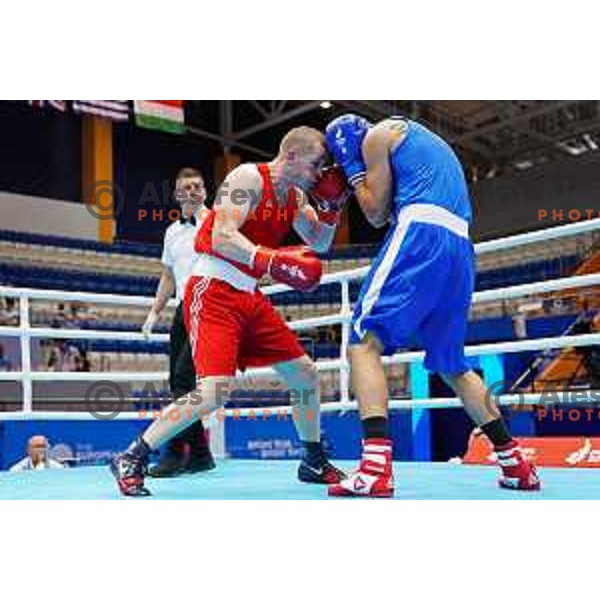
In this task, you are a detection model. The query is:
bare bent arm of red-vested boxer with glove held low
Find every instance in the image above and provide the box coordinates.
[212,164,262,266]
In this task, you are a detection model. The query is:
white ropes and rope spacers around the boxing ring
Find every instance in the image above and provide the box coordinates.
[0,219,600,420]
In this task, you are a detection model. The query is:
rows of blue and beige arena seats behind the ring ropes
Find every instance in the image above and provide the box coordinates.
[0,231,591,386]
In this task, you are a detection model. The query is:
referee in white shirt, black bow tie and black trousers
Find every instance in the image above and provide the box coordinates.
[142,167,215,477]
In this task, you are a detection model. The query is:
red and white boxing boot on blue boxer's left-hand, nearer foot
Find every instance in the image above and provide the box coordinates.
[327,438,394,498]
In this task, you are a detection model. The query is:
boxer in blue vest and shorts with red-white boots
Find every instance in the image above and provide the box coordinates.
[326,114,540,497]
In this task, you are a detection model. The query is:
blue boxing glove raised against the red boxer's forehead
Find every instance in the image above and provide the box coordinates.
[325,114,371,187]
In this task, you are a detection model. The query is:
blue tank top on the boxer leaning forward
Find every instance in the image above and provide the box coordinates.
[390,120,472,223]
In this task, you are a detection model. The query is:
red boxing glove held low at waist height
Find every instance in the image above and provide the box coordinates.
[253,246,323,292]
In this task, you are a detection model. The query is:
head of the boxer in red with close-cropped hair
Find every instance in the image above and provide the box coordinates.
[276,127,327,190]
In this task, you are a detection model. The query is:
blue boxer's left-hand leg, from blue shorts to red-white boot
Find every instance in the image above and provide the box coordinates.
[329,223,443,498]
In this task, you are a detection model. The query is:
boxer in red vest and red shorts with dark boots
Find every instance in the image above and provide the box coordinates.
[111,127,347,496]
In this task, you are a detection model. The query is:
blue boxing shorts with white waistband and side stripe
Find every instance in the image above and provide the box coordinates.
[350,204,475,374]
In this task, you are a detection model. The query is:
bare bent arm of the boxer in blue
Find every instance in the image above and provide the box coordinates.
[355,127,397,227]
